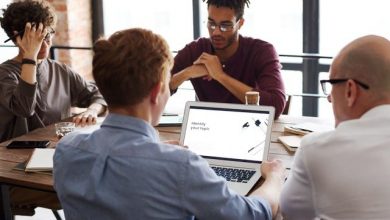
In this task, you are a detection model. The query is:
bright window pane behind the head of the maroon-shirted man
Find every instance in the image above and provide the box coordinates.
[200,0,302,54]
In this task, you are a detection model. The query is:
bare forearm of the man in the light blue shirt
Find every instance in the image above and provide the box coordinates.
[250,176,283,216]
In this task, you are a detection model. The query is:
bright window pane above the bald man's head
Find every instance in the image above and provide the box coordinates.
[320,0,390,56]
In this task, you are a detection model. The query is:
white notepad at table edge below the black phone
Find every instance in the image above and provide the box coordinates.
[25,148,55,172]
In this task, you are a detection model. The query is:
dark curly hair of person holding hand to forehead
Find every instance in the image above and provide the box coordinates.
[0,0,57,37]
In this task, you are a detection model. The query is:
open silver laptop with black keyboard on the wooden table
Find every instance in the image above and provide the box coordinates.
[180,102,275,195]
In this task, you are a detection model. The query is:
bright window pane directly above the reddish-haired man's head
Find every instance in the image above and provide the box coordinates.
[103,0,193,51]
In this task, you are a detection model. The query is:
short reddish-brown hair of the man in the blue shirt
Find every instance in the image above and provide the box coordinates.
[92,28,173,107]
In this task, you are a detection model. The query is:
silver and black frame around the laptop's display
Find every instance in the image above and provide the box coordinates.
[180,101,275,163]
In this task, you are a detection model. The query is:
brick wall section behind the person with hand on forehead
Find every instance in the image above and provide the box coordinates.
[47,0,93,80]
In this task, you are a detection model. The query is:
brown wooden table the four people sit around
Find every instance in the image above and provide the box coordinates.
[0,115,333,220]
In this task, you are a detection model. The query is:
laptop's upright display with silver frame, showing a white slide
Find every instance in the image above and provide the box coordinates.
[180,102,274,161]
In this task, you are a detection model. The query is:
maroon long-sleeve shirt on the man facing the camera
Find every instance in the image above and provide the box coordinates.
[172,35,286,118]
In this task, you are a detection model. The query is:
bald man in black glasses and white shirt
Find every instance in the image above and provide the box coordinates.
[281,36,390,220]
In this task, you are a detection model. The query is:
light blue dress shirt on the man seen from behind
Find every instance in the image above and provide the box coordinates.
[54,114,272,220]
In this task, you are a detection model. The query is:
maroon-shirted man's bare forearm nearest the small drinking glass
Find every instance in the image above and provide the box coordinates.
[216,74,253,103]
